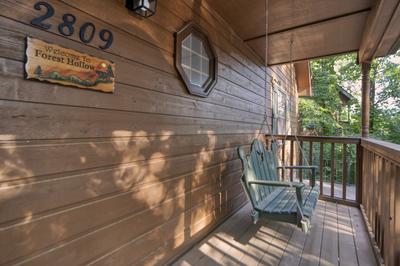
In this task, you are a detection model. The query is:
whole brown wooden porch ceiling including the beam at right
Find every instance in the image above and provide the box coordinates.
[206,0,400,65]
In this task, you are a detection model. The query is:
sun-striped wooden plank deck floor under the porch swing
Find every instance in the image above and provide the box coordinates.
[173,201,377,266]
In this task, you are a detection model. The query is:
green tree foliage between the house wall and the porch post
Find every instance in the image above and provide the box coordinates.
[299,55,360,136]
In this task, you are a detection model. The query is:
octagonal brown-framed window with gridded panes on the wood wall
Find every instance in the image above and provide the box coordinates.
[175,24,217,97]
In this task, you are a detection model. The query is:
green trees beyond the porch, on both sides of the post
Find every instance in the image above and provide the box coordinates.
[299,52,400,143]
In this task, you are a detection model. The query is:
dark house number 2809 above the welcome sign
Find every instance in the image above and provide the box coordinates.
[31,1,114,50]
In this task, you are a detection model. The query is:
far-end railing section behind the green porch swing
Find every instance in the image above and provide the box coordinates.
[266,135,361,205]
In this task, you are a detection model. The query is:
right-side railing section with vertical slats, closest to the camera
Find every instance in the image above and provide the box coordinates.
[361,139,400,266]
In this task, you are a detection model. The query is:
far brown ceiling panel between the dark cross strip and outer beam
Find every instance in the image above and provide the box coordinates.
[268,11,370,65]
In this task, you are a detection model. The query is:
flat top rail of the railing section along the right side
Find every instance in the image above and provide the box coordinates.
[361,138,400,165]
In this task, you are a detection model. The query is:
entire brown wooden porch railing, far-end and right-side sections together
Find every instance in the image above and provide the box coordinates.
[266,135,400,266]
